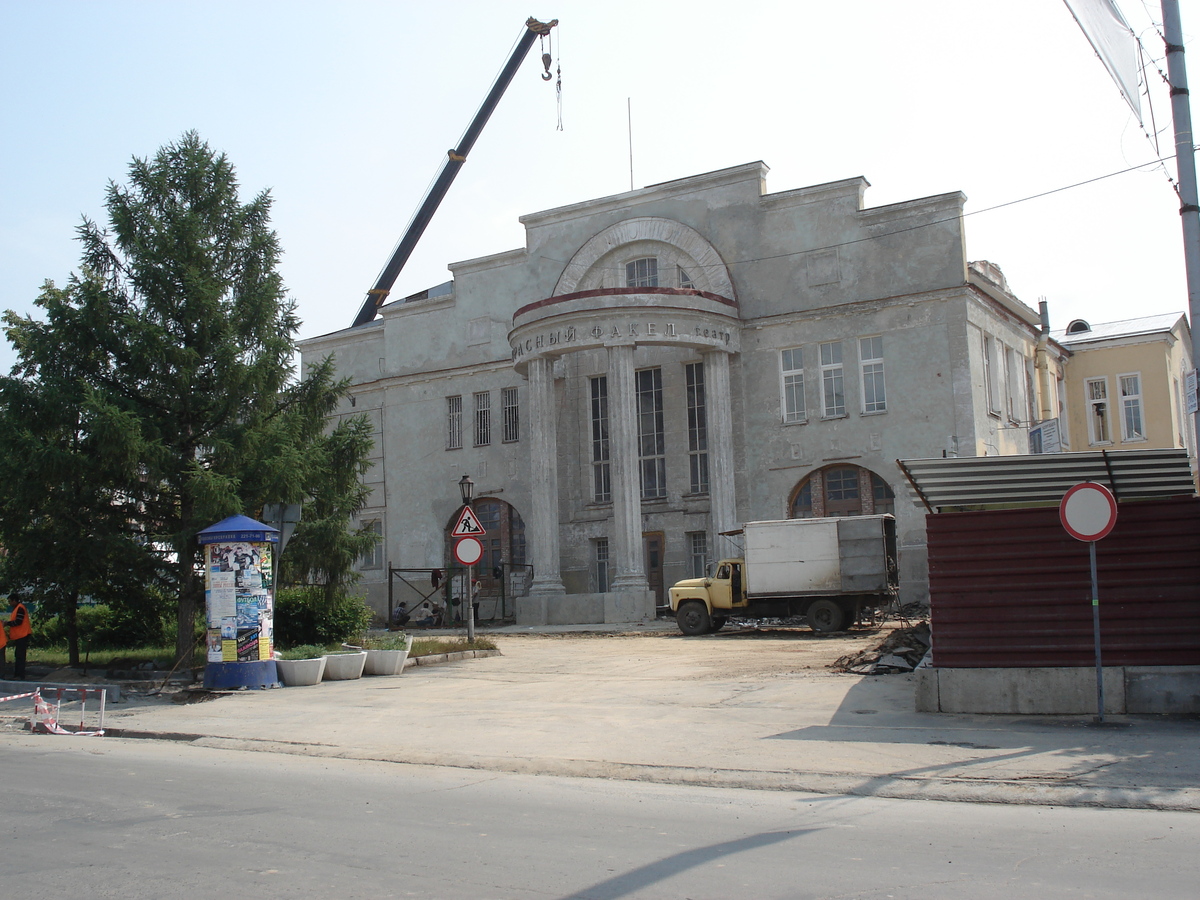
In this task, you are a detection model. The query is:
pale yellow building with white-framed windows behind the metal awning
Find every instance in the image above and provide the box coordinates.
[1054,312,1195,456]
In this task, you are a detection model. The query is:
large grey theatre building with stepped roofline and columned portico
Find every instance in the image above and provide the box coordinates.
[301,162,1063,624]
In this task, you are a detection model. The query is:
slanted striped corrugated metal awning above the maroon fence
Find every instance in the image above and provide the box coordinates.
[896,450,1196,512]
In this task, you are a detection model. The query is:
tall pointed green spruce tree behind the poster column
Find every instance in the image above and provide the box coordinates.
[0,132,368,672]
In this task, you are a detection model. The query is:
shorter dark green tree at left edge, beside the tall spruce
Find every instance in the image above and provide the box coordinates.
[0,336,157,664]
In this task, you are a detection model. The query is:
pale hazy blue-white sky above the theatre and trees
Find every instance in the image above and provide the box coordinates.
[0,0,1200,371]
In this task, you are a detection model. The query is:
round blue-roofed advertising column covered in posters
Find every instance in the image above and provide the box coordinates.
[199,516,280,689]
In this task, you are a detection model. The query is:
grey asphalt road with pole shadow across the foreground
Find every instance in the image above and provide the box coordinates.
[0,737,1200,900]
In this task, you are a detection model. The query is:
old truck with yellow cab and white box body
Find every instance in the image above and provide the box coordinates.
[671,515,899,635]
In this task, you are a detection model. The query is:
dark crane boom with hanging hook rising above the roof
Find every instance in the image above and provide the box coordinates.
[350,18,558,328]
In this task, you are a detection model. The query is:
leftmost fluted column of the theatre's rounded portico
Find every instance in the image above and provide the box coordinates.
[527,356,565,594]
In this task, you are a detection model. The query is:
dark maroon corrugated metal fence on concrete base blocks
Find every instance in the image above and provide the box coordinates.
[926,497,1200,667]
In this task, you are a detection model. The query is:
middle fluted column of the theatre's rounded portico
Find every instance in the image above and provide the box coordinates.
[608,344,650,590]
